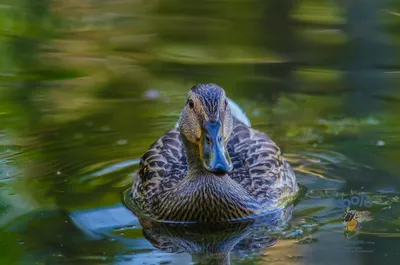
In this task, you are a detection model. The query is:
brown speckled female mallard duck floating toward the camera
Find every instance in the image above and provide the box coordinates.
[129,84,298,222]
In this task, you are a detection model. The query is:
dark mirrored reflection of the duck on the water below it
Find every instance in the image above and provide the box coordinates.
[139,206,293,265]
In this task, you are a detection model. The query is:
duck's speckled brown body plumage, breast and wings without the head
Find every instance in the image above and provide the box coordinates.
[131,84,298,222]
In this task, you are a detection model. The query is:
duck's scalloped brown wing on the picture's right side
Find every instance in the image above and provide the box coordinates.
[228,120,298,206]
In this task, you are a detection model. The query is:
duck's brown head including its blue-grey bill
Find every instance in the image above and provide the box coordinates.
[179,84,233,175]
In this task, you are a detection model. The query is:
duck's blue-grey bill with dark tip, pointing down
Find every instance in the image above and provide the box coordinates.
[200,121,233,175]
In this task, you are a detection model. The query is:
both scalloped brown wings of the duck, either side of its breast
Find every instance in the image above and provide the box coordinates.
[132,119,298,211]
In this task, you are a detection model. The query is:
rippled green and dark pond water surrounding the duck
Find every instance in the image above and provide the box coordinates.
[0,0,400,265]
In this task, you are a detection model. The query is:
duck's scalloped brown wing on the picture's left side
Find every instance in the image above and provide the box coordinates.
[131,127,187,210]
